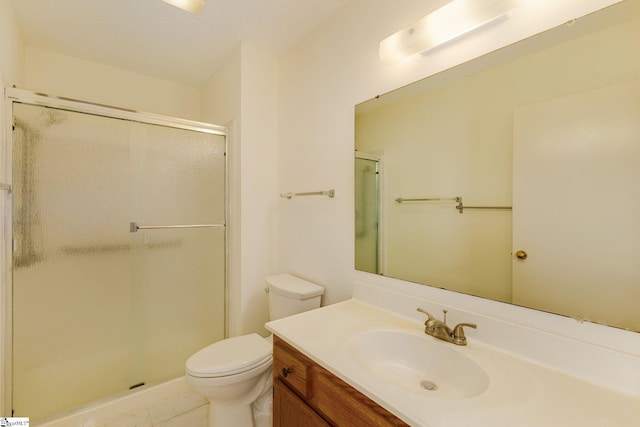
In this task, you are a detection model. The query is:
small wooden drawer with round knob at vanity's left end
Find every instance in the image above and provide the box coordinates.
[273,336,311,398]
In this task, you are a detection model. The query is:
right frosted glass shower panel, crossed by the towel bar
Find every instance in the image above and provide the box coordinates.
[131,124,225,383]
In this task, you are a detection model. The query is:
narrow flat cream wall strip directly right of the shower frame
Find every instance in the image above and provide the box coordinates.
[234,44,279,334]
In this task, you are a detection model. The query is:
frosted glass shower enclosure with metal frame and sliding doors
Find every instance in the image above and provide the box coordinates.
[2,89,226,421]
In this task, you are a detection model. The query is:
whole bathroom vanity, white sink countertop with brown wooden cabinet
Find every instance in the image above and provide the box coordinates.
[266,284,640,427]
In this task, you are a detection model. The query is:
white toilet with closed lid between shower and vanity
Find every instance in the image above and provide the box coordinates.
[186,274,324,427]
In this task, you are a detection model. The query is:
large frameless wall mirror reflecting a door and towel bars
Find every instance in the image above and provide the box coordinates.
[355,0,640,331]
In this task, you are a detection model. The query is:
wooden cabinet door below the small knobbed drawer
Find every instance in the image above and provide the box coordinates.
[273,378,329,427]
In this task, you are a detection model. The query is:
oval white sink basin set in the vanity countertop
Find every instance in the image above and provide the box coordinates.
[351,331,489,400]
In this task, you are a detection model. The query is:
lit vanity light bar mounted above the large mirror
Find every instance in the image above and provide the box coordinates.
[380,0,520,63]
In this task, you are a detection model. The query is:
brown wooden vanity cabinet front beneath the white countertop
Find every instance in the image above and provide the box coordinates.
[273,336,408,427]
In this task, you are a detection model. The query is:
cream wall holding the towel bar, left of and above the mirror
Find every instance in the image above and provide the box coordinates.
[278,0,616,344]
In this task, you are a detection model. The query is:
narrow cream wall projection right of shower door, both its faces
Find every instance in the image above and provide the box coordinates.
[202,44,278,336]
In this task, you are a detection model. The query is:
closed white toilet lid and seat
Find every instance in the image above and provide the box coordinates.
[186,334,272,378]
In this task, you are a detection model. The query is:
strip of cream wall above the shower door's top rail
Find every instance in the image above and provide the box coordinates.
[21,46,200,120]
